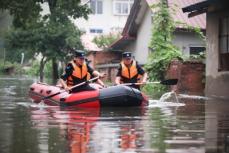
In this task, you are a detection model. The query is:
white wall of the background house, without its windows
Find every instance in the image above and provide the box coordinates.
[74,0,128,34]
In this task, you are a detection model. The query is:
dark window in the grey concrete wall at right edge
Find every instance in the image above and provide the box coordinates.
[219,17,229,71]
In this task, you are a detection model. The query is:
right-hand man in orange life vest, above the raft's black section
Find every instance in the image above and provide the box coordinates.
[115,52,148,89]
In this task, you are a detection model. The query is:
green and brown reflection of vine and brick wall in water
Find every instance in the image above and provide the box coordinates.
[147,98,204,153]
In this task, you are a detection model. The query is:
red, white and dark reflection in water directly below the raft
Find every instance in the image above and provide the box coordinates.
[28,107,144,153]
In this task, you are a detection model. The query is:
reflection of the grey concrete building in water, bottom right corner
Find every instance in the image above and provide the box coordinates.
[205,100,229,153]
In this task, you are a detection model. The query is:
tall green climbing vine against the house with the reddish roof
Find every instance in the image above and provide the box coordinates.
[145,0,181,80]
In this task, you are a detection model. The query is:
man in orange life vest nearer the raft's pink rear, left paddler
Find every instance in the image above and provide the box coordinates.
[60,50,104,92]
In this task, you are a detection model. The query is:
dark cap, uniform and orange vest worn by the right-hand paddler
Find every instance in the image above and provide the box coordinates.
[116,52,145,89]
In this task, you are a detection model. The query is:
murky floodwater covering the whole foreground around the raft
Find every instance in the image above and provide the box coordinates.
[0,77,229,153]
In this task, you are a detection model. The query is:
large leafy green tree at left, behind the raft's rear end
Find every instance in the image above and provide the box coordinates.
[0,0,90,81]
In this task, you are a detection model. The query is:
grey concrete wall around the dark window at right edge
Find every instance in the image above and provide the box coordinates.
[205,11,229,98]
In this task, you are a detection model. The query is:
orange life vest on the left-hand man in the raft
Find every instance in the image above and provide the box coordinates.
[67,61,89,86]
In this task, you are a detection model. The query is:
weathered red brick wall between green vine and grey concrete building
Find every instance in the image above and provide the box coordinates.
[167,61,205,95]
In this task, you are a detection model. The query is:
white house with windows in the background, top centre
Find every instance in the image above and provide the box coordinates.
[74,0,134,35]
